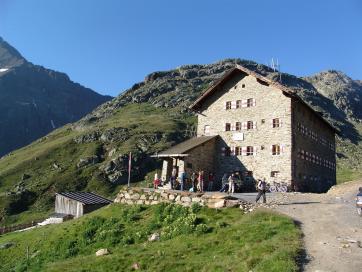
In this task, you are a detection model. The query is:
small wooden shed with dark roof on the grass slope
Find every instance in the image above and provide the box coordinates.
[55,192,113,218]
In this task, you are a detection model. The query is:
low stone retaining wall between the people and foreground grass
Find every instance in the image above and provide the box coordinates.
[114,188,246,208]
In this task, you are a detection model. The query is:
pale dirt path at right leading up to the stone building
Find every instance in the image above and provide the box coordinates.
[269,181,362,272]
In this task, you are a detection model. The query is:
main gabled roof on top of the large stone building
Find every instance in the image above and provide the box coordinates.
[189,64,339,133]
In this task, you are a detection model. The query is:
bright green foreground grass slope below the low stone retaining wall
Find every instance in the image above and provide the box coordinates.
[0,203,302,272]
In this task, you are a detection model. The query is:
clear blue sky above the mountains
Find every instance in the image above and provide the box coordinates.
[0,0,362,96]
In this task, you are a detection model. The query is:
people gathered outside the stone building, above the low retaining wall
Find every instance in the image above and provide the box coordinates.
[153,168,266,203]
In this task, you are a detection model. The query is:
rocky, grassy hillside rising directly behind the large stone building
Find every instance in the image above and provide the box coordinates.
[0,59,362,224]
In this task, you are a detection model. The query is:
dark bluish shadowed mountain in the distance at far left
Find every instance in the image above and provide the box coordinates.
[0,38,111,156]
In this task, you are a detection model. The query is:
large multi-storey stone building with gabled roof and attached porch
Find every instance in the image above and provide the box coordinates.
[156,65,336,192]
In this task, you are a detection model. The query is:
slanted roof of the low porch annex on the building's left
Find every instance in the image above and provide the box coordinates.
[152,136,217,158]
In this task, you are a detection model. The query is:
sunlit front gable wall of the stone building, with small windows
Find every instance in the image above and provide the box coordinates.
[197,74,292,184]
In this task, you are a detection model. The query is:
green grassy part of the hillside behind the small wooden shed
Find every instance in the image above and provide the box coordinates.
[0,104,194,225]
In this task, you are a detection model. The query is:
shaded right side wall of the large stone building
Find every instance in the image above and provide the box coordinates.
[292,101,336,192]
